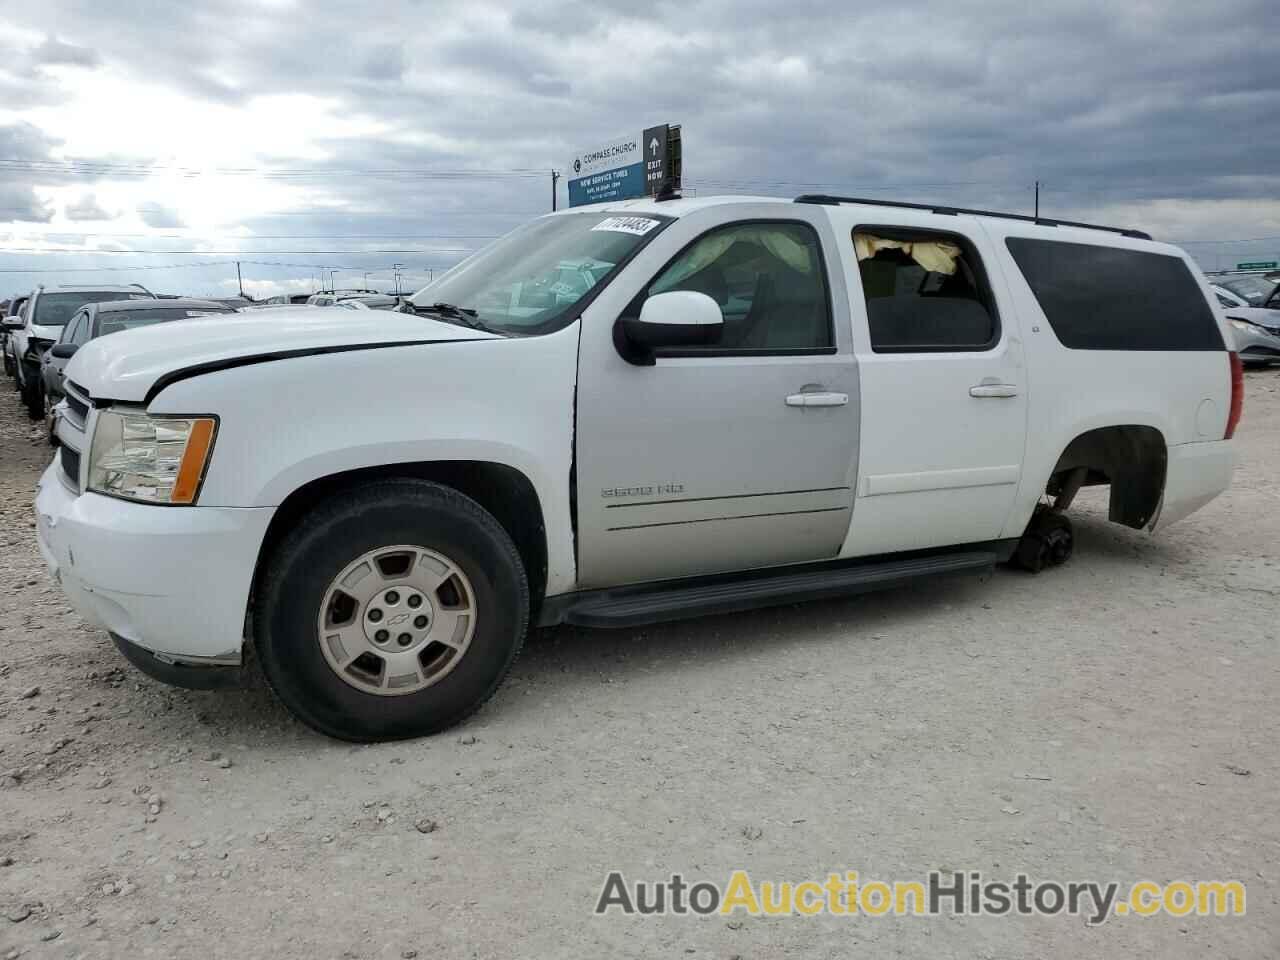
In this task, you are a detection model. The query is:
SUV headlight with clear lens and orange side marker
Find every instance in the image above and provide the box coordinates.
[88,410,218,504]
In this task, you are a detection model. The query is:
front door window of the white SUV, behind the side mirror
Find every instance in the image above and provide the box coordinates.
[645,221,835,353]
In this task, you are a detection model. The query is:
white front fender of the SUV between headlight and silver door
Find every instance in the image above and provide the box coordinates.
[148,324,577,593]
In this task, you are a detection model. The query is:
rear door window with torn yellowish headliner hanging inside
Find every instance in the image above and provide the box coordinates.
[854,227,1000,353]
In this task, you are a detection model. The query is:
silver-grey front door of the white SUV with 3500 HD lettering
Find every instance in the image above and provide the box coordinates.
[576,205,859,586]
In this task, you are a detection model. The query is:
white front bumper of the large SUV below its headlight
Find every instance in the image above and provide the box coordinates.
[36,460,274,682]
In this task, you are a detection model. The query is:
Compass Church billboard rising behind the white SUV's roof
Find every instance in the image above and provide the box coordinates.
[568,123,681,206]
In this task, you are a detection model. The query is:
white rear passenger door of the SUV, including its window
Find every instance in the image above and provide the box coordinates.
[833,209,1028,557]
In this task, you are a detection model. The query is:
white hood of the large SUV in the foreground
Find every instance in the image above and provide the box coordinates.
[65,307,502,403]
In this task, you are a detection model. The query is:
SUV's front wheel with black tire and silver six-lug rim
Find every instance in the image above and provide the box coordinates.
[253,479,529,742]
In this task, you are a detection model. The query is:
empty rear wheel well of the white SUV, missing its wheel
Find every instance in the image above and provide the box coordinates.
[1047,425,1169,530]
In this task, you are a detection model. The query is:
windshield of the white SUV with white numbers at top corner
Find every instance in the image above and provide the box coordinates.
[412,212,669,334]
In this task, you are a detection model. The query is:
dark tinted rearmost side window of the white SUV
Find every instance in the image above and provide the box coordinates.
[1006,237,1225,349]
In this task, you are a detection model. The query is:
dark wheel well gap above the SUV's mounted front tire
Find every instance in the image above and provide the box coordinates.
[251,460,547,622]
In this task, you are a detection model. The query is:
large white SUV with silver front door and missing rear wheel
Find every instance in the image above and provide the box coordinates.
[36,197,1242,740]
